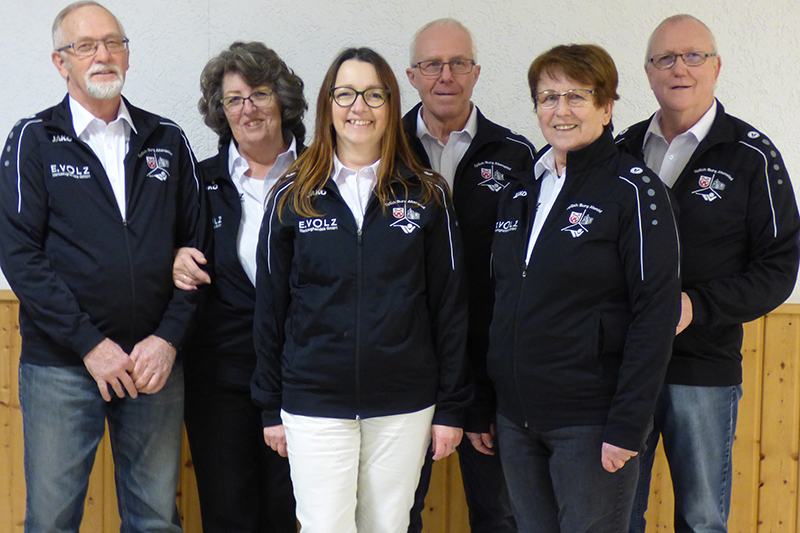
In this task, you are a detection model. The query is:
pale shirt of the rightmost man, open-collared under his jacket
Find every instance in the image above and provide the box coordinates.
[642,100,717,187]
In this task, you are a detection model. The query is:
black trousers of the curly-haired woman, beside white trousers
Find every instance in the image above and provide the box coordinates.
[184,372,297,533]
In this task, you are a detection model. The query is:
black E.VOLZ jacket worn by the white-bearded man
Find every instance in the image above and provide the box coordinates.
[0,97,204,366]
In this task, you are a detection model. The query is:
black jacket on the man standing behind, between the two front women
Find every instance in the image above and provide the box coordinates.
[403,104,535,433]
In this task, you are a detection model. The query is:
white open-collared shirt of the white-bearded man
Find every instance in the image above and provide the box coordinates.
[69,96,136,220]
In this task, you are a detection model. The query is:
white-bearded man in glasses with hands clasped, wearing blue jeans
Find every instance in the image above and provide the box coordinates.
[0,2,201,532]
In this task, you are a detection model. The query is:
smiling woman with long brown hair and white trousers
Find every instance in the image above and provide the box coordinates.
[253,48,471,533]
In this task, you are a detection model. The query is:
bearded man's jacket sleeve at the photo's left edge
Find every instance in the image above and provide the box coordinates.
[0,119,105,357]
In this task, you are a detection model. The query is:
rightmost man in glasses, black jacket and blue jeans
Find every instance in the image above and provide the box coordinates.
[617,15,800,533]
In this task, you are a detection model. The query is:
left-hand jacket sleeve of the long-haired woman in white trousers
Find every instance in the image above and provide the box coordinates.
[251,186,294,427]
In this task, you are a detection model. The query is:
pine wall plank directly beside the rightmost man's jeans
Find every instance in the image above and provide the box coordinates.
[728,318,765,533]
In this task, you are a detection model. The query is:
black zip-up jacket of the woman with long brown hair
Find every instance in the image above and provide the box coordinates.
[253,166,472,427]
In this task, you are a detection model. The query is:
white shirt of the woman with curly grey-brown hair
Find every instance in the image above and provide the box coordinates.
[228,136,297,286]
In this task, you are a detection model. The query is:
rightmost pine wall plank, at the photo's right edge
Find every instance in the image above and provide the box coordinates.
[759,313,800,532]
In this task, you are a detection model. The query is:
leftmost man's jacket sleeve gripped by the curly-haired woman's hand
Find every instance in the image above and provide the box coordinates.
[154,123,206,347]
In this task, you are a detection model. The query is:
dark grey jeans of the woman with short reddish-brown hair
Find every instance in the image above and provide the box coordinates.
[497,415,639,533]
